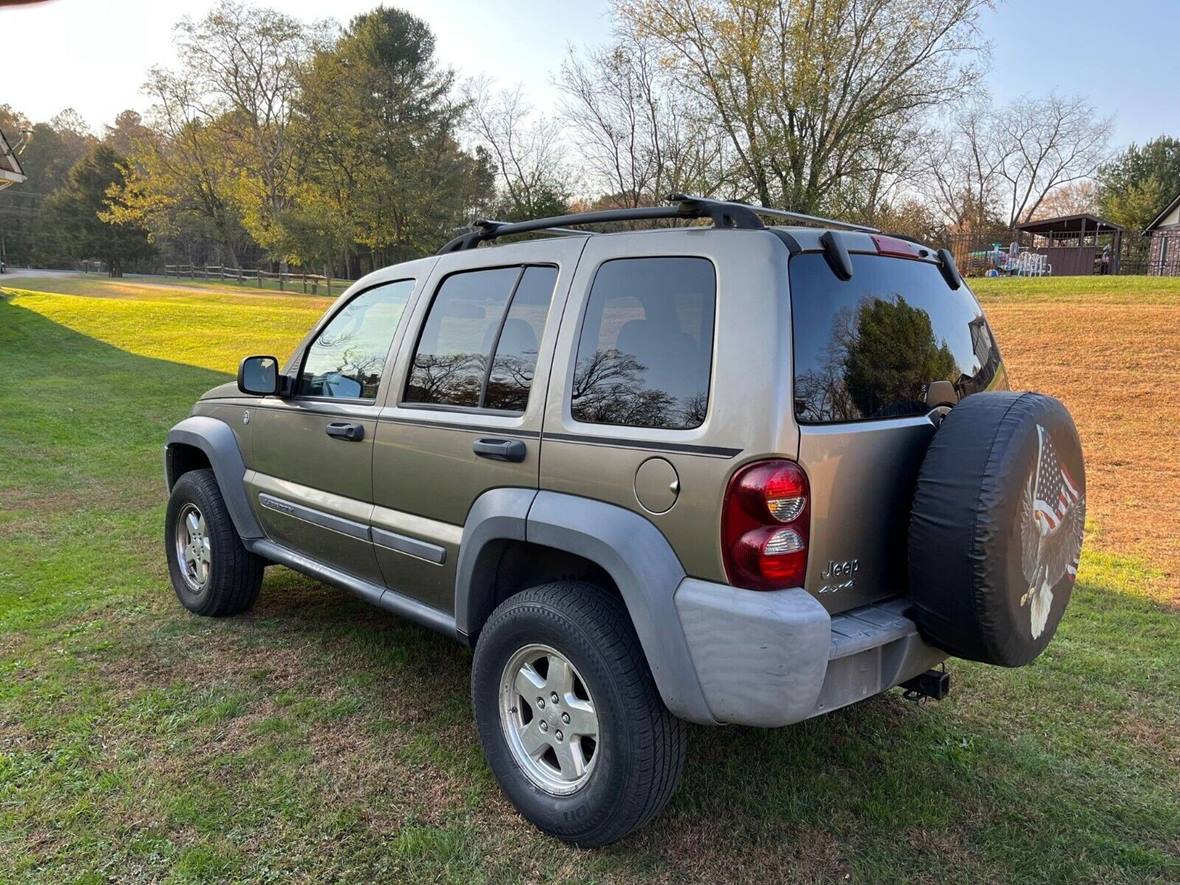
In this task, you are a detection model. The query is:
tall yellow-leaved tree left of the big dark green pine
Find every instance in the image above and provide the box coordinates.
[112,0,314,266]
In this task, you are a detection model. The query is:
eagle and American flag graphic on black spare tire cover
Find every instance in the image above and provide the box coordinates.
[1020,424,1086,640]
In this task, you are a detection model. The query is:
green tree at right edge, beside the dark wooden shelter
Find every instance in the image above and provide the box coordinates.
[1097,136,1180,231]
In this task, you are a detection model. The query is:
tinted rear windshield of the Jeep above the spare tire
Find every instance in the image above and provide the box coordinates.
[789,253,1007,424]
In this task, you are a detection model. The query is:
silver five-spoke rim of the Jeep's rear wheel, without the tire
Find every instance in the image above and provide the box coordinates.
[500,644,598,795]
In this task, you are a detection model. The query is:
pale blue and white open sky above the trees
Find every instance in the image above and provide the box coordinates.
[0,0,1180,146]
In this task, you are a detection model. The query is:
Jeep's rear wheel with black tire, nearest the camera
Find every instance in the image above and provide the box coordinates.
[472,582,686,847]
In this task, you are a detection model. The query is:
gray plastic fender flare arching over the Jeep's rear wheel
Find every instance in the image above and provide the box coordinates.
[455,489,716,723]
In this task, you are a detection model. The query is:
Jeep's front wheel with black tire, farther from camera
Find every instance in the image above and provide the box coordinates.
[164,470,266,617]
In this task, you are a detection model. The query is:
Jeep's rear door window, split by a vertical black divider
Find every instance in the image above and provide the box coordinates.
[405,267,557,412]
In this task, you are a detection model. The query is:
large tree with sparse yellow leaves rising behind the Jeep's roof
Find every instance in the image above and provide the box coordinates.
[616,0,989,211]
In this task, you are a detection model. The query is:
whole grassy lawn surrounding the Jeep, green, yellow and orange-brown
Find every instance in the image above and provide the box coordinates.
[0,277,1180,883]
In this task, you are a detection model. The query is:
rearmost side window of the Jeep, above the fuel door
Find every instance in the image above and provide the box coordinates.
[570,257,716,430]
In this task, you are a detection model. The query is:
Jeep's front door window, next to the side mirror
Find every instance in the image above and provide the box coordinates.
[296,280,414,400]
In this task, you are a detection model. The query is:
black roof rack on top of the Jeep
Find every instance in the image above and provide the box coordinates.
[438,194,877,255]
